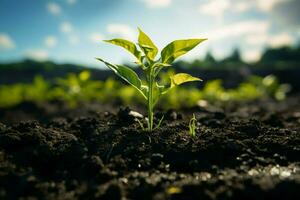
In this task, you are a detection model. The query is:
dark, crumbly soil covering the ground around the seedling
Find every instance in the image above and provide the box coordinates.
[0,96,300,200]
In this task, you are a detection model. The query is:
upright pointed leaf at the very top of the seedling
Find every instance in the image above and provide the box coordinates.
[138,28,158,60]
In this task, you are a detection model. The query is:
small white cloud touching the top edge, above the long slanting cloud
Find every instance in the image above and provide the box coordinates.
[199,0,231,19]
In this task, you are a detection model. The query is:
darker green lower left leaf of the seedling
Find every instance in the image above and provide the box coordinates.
[96,58,148,99]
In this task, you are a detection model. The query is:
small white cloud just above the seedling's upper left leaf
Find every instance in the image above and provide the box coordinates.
[107,24,135,40]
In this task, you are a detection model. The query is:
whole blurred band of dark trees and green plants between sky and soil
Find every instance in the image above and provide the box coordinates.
[0,44,300,109]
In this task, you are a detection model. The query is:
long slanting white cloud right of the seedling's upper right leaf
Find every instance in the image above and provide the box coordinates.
[207,20,270,40]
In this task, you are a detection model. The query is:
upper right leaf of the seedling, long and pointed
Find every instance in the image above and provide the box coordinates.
[161,39,206,64]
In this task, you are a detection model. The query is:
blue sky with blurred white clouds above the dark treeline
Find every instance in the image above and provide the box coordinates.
[0,0,300,67]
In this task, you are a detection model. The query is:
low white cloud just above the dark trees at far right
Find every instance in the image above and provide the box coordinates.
[246,32,294,48]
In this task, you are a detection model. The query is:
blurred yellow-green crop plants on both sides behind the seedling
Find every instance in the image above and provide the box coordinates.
[0,70,290,109]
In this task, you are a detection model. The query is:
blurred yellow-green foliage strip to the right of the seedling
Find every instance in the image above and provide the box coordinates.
[159,72,290,108]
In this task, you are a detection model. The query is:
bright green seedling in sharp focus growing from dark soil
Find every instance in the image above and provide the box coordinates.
[97,29,206,131]
